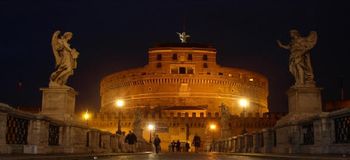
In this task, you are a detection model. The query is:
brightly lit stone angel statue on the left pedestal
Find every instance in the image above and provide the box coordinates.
[49,31,79,86]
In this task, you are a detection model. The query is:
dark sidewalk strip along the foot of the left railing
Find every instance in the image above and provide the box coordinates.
[0,152,152,160]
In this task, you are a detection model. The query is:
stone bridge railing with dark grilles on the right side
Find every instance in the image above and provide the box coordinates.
[208,108,350,154]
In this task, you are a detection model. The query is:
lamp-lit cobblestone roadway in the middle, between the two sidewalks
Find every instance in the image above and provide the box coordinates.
[98,153,280,160]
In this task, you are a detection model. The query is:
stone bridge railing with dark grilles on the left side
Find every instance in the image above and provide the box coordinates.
[0,103,152,154]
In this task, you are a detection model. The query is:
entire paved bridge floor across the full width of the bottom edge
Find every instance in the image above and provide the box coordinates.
[0,152,350,160]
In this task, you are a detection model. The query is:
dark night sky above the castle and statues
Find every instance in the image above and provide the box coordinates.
[0,0,350,112]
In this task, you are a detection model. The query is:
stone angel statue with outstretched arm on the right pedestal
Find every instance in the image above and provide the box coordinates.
[277,29,317,86]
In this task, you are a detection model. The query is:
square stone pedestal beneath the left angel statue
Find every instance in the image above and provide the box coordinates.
[40,86,77,121]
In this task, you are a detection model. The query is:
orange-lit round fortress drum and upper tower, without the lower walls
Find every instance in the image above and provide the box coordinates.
[100,43,268,116]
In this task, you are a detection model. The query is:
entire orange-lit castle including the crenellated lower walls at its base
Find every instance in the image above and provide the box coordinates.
[89,40,279,151]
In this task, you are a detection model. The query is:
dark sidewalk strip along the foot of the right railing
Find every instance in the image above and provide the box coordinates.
[216,152,350,160]
